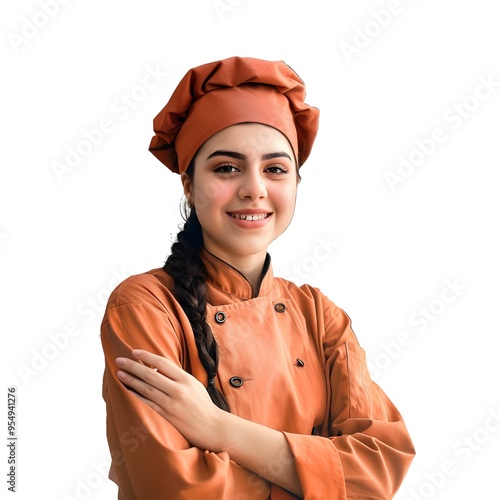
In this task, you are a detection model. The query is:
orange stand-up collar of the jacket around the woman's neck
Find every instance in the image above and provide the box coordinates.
[200,248,273,299]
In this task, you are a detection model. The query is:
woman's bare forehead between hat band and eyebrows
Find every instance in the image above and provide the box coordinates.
[197,123,294,158]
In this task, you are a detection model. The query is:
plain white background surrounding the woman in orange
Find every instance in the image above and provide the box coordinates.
[0,0,500,500]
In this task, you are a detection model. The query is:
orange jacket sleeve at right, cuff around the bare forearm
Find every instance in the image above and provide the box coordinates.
[285,298,415,500]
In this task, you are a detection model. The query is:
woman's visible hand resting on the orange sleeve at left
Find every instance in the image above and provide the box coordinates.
[116,349,222,452]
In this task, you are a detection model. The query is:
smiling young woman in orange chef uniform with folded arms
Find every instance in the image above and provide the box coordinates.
[101,57,414,500]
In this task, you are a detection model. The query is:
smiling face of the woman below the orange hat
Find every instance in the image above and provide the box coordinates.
[182,123,298,263]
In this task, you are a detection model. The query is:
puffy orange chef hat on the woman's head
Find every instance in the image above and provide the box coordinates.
[149,57,319,174]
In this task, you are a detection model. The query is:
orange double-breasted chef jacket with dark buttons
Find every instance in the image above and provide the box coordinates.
[101,250,414,500]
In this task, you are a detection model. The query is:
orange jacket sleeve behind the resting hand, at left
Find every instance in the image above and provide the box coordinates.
[101,279,270,500]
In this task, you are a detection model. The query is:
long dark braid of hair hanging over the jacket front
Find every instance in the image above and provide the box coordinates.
[163,209,230,411]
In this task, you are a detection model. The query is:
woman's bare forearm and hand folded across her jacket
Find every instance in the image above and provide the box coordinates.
[117,350,302,496]
